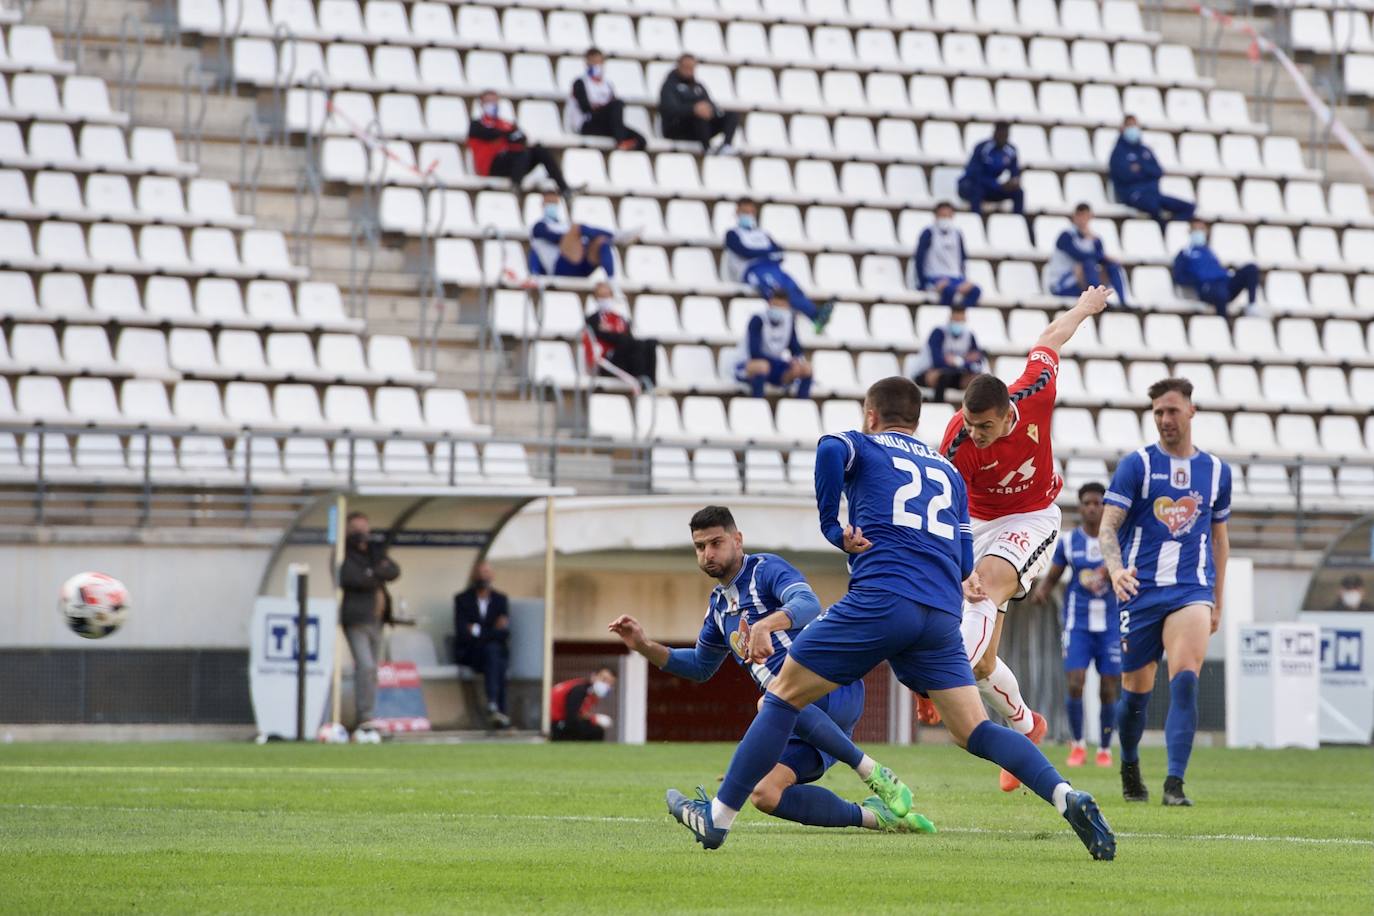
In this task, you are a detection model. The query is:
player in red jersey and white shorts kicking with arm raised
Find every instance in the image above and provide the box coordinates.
[918,286,1110,792]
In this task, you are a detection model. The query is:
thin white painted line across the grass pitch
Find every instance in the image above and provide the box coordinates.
[0,802,1374,846]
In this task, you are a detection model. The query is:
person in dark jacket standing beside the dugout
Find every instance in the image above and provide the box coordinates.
[339,512,401,731]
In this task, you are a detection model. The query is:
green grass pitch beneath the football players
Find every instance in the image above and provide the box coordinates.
[0,744,1374,913]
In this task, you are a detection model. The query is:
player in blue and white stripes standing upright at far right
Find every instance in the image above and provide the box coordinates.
[1098,379,1231,805]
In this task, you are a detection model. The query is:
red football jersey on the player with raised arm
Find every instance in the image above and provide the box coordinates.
[940,346,1063,522]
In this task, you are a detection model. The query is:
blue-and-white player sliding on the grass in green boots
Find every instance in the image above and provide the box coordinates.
[609,505,934,832]
